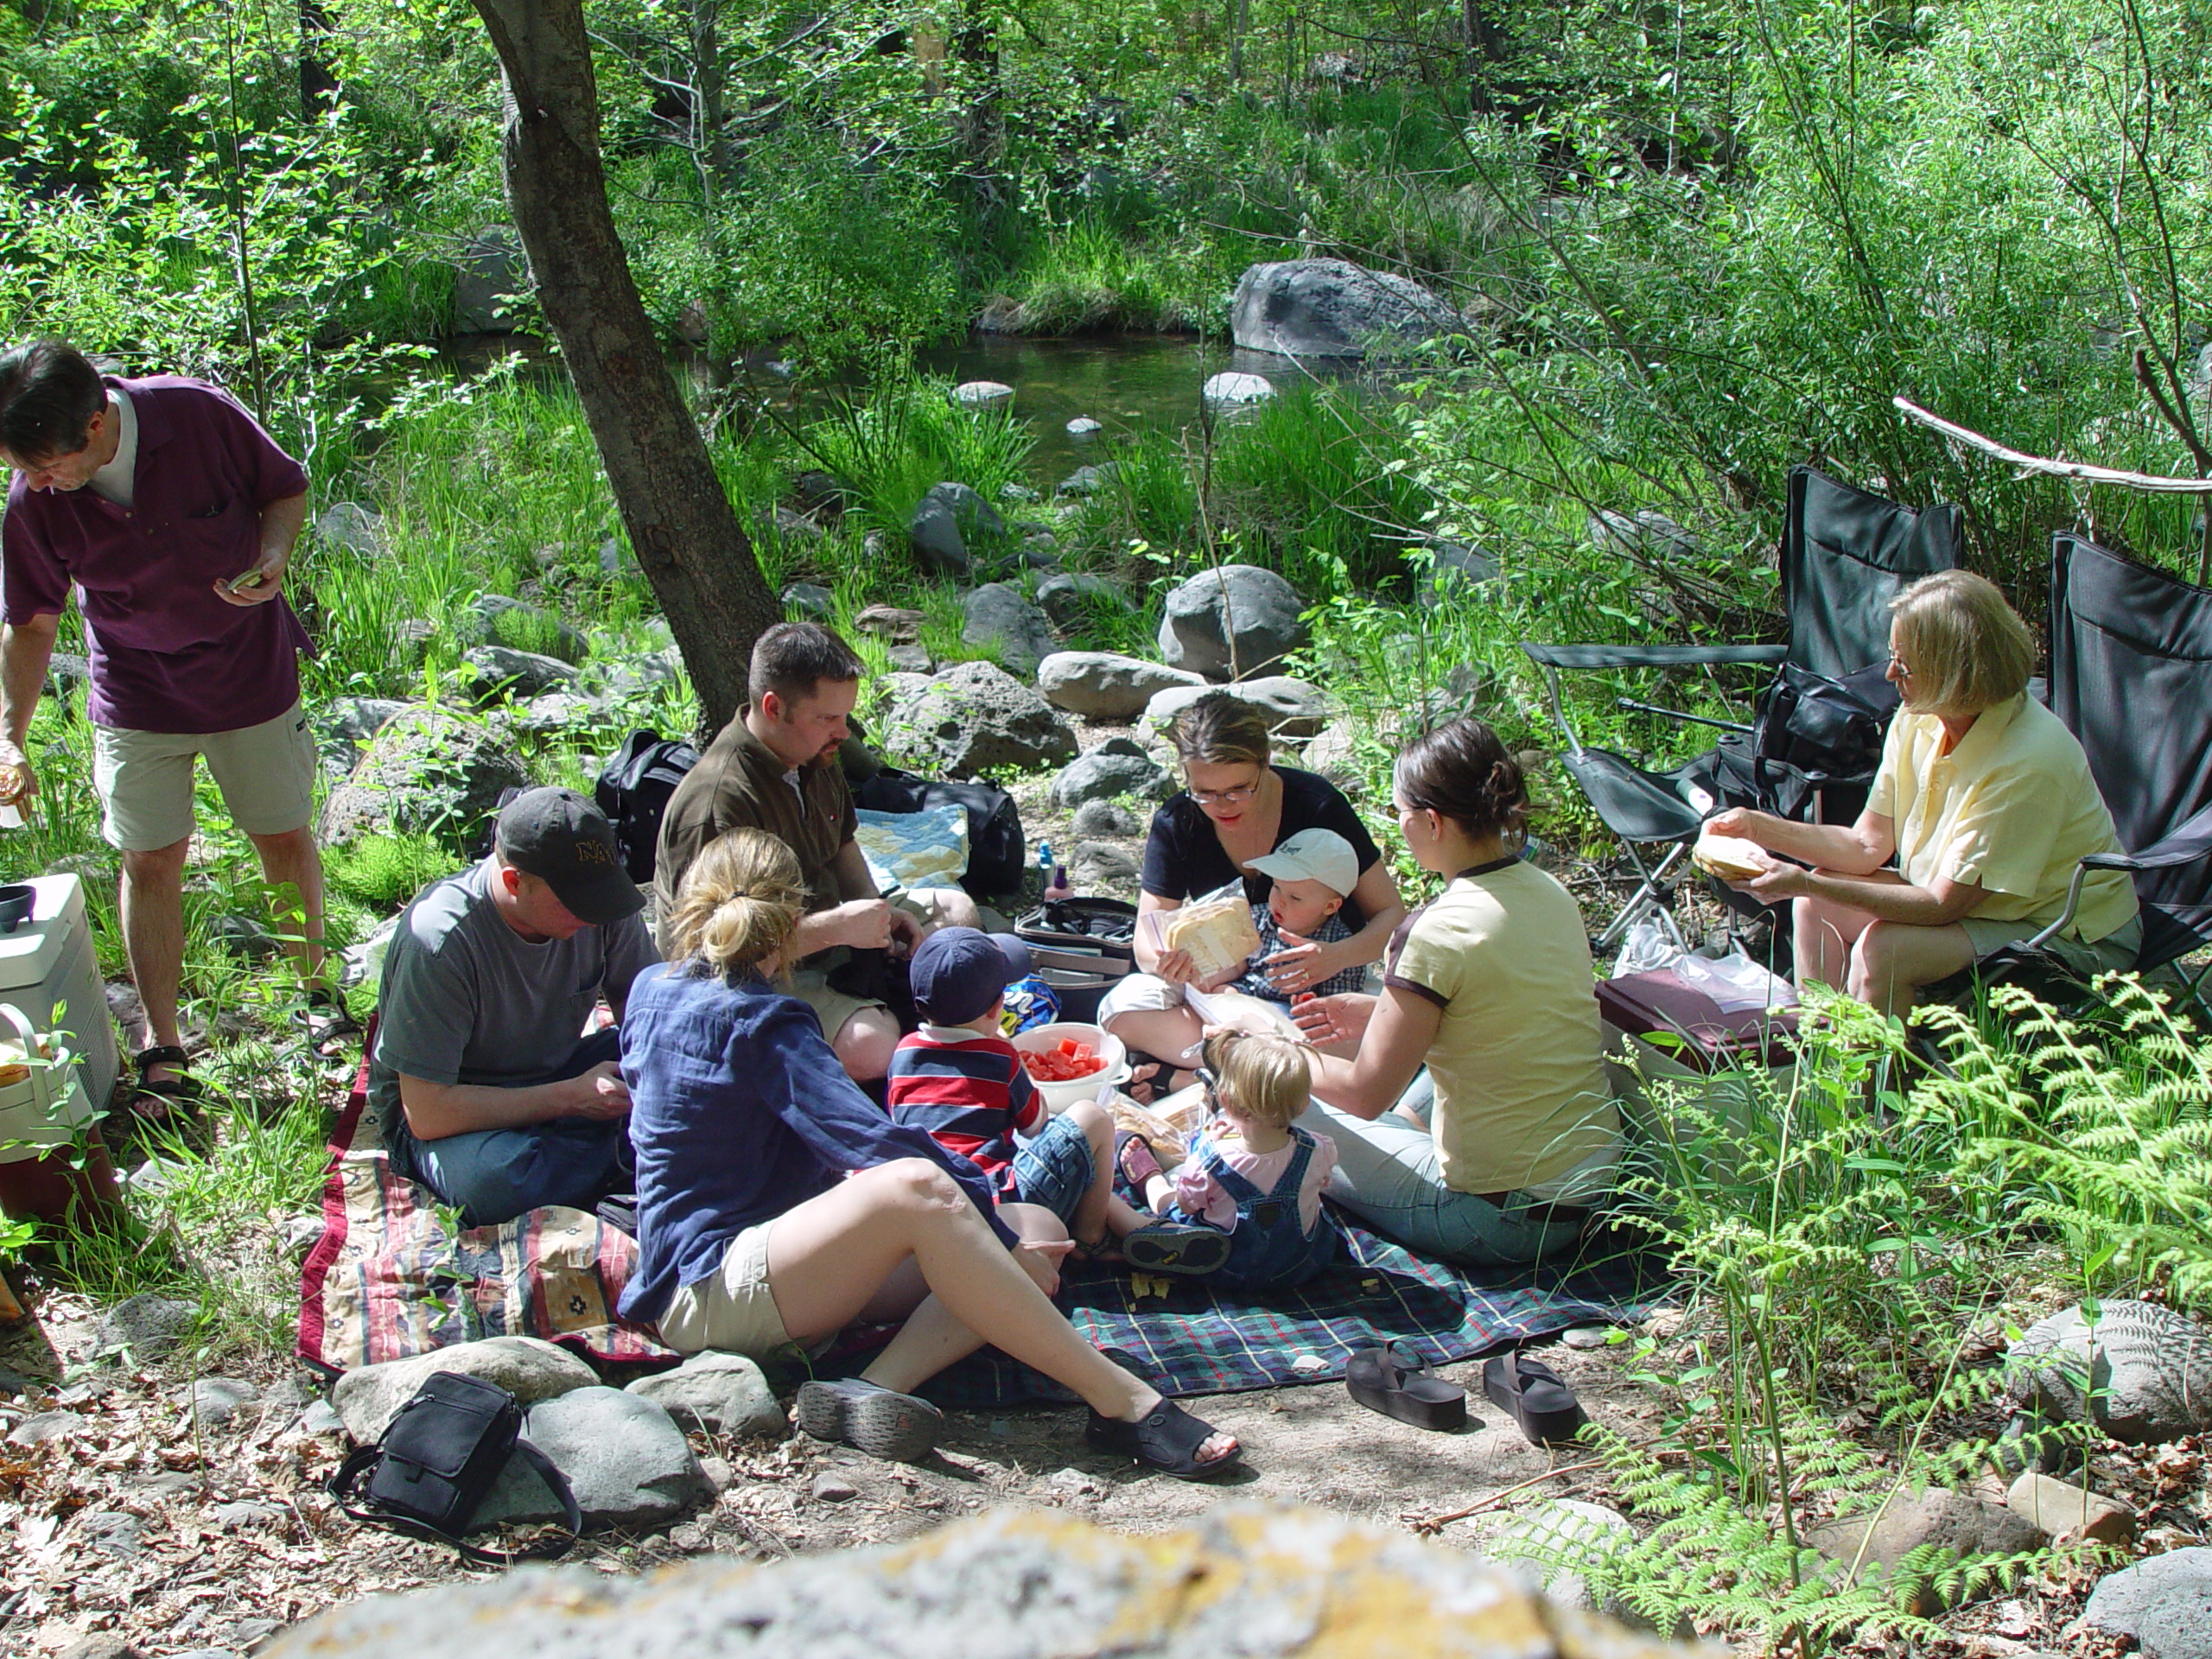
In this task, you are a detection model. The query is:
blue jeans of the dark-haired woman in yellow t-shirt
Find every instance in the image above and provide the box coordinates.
[1299,1071,1581,1268]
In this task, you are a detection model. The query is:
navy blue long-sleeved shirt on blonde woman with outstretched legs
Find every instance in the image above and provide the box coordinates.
[620,967,1015,1320]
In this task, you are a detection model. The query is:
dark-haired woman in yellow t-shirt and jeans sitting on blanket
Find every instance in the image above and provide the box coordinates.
[1292,719,1619,1265]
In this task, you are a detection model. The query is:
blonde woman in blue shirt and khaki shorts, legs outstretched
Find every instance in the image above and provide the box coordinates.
[621,830,1239,1480]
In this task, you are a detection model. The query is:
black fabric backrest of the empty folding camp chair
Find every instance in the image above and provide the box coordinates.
[1781,467,1960,679]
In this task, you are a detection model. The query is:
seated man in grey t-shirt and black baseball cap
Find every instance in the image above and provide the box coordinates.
[370,790,659,1228]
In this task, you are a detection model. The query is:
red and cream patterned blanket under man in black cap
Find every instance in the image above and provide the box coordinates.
[296,1052,677,1371]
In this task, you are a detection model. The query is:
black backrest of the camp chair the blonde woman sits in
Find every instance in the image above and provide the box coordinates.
[2050,531,2212,969]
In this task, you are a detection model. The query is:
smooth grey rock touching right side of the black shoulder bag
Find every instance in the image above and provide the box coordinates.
[478,1385,710,1526]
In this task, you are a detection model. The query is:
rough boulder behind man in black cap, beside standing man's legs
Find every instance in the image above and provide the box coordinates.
[319,703,531,847]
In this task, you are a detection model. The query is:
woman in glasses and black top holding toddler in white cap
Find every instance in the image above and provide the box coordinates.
[1099,690,1405,1082]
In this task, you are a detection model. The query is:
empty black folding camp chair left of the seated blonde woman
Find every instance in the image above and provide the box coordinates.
[1522,467,1960,953]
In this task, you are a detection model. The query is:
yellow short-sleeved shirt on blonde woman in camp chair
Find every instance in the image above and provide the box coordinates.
[1867,692,2134,944]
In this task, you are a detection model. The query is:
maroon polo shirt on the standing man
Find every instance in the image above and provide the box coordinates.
[0,387,312,732]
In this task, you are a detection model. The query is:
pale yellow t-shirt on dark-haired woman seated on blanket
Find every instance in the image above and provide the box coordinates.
[1382,861,1619,1197]
